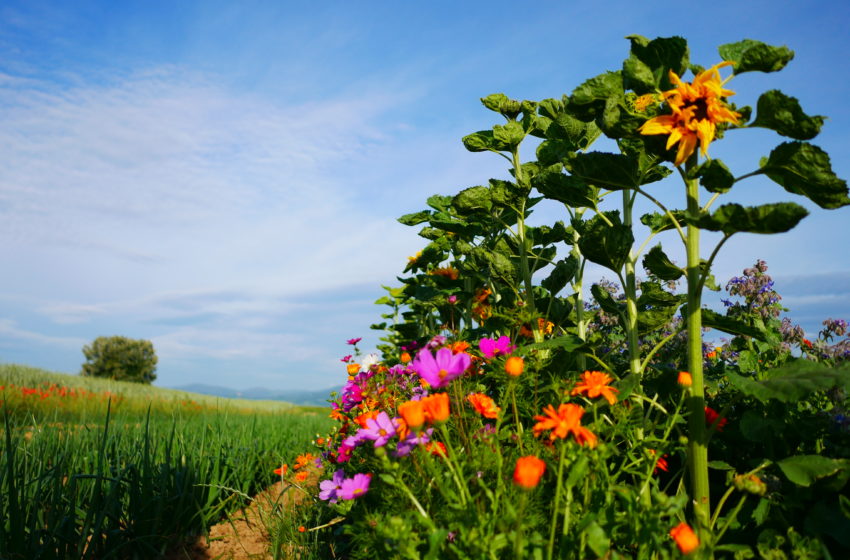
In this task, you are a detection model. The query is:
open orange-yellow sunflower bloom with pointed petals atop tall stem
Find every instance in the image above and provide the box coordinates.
[639,61,741,165]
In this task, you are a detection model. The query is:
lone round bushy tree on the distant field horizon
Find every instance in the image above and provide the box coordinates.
[81,336,157,383]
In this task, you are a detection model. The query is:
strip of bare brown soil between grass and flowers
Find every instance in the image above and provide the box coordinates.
[163,476,310,560]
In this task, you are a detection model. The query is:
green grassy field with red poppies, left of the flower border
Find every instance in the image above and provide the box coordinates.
[0,365,329,559]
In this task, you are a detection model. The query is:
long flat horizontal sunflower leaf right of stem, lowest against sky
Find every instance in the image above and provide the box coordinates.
[696,202,809,235]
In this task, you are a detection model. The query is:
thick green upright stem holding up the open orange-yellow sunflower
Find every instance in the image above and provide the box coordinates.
[685,153,711,533]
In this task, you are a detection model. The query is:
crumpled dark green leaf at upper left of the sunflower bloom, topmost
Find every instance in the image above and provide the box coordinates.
[623,35,689,95]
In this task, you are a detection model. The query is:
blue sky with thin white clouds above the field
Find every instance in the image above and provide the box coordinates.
[0,0,850,389]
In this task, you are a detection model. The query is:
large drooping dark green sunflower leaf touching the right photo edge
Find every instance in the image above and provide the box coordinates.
[759,142,850,208]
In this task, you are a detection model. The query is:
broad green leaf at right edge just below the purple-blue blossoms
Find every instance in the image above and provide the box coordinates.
[726,360,850,402]
